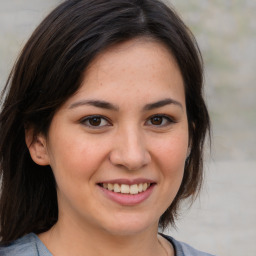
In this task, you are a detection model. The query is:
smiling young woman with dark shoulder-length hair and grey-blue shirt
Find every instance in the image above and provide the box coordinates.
[0,0,210,256]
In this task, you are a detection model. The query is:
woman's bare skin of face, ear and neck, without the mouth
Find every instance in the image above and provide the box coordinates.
[26,39,189,256]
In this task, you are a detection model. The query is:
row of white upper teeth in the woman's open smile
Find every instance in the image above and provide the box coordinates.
[102,183,150,195]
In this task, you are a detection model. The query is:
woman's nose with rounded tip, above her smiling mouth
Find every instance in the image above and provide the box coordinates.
[110,129,151,170]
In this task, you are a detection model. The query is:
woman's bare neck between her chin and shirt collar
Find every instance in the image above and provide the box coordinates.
[39,216,168,256]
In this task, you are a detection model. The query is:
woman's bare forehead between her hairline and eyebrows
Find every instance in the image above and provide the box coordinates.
[63,39,184,108]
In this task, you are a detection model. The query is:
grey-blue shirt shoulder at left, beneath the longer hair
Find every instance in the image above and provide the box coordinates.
[0,233,51,256]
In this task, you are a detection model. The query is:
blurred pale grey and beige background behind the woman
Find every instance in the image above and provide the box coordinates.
[0,0,256,256]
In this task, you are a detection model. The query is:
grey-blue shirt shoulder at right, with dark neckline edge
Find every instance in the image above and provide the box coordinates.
[161,234,217,256]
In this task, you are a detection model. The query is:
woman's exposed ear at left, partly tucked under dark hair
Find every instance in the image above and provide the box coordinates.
[25,128,50,165]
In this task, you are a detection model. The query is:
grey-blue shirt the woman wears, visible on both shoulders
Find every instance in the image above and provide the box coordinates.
[0,233,216,256]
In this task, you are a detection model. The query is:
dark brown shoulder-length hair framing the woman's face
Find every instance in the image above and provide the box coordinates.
[0,0,210,242]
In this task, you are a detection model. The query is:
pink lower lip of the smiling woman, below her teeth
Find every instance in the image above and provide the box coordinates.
[99,184,155,206]
